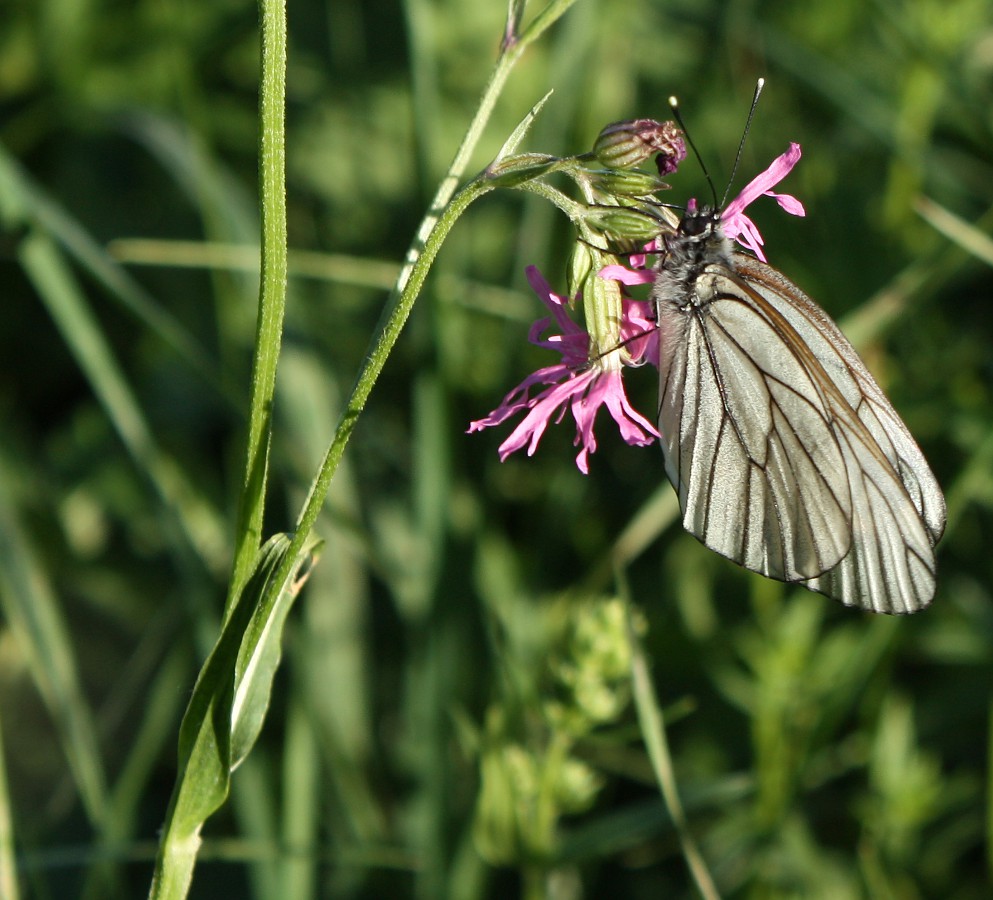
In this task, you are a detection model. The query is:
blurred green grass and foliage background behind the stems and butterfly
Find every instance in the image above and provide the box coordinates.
[0,0,993,900]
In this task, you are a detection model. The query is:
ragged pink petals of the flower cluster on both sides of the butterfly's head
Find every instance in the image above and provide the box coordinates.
[469,141,804,474]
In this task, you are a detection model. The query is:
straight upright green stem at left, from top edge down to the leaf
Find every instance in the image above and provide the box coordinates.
[226,0,287,610]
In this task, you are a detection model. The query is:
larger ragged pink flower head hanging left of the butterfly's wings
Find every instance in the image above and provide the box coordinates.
[469,266,659,474]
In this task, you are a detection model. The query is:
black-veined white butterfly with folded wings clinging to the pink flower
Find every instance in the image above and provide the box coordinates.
[651,145,945,613]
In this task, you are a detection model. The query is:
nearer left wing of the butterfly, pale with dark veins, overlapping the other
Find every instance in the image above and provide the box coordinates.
[658,262,851,581]
